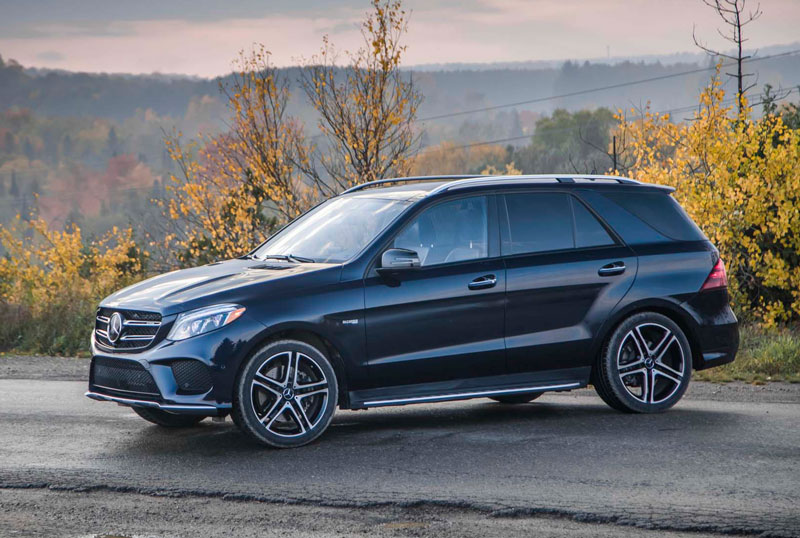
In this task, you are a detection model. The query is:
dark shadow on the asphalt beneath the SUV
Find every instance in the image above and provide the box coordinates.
[115,398,736,458]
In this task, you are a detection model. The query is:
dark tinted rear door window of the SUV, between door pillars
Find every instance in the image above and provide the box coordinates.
[502,193,614,256]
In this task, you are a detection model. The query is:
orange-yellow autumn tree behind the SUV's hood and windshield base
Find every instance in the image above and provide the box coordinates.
[162,46,318,264]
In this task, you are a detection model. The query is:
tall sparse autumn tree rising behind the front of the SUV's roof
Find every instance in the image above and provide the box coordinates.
[301,0,422,190]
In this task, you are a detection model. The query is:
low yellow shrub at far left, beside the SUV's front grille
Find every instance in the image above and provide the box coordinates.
[0,217,146,354]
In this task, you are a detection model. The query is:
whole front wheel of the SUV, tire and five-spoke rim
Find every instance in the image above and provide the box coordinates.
[231,340,339,448]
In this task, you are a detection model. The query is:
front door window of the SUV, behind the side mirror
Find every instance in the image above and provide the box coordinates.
[394,196,489,267]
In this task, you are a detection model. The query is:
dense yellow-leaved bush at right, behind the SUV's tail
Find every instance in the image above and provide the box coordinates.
[619,71,800,324]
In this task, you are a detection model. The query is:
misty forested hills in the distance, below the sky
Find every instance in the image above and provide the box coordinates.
[0,47,800,234]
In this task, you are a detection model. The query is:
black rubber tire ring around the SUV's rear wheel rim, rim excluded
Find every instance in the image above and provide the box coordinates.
[602,312,692,413]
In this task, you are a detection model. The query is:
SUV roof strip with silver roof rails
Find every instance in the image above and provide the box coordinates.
[344,174,674,197]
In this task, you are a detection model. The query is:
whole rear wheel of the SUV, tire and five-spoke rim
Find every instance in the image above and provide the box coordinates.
[592,312,692,413]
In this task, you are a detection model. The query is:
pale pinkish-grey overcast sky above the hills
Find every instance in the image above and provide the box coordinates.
[0,0,800,76]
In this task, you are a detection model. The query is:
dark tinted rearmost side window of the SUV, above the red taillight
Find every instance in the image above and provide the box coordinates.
[603,188,706,241]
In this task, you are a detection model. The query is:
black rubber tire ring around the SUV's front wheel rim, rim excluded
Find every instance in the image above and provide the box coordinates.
[233,340,339,448]
